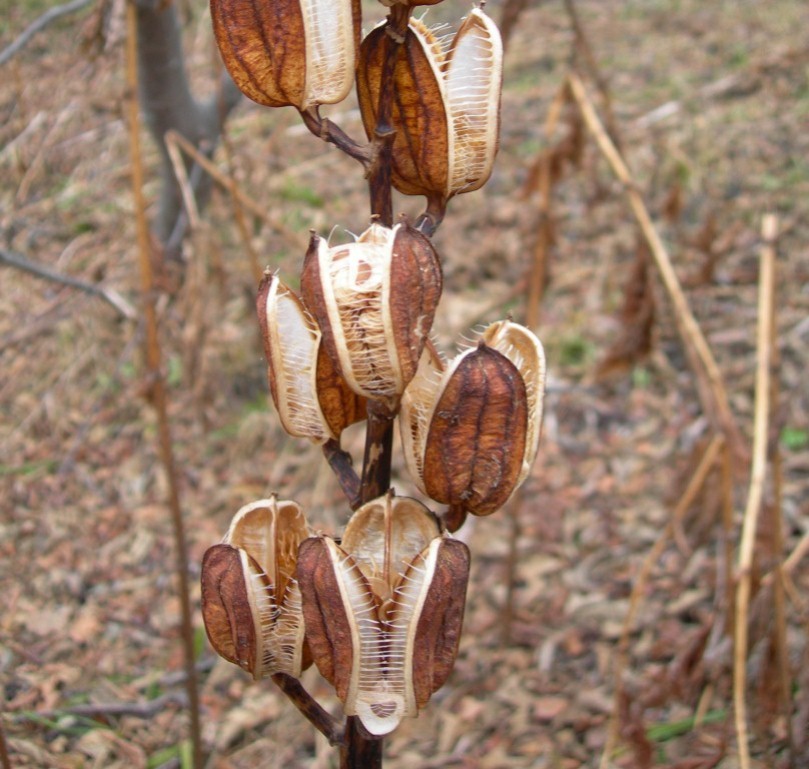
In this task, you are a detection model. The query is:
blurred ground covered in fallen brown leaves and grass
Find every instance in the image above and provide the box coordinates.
[0,0,809,769]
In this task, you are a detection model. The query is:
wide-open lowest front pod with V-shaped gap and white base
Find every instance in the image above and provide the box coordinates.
[298,494,469,736]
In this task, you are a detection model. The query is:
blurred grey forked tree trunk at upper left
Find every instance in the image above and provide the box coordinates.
[135,0,241,257]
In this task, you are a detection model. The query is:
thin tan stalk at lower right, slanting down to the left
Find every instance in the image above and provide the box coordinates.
[599,433,725,769]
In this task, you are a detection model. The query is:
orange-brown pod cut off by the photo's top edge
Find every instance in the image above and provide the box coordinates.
[211,0,360,111]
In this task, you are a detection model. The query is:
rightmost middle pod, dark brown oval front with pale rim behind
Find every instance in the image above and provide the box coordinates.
[400,321,545,522]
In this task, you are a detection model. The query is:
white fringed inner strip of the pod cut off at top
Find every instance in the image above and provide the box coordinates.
[300,0,355,109]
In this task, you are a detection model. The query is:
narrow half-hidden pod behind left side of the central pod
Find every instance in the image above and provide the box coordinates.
[256,273,365,443]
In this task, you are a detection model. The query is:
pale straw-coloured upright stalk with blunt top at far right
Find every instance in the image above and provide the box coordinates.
[733,215,778,769]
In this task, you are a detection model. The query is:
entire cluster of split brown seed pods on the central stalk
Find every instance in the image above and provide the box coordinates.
[202,0,545,739]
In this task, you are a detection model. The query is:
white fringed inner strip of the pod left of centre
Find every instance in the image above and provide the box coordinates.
[266,280,326,443]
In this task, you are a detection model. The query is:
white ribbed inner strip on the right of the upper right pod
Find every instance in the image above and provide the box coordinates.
[445,9,503,194]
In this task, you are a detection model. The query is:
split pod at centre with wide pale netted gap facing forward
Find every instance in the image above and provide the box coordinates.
[301,222,442,403]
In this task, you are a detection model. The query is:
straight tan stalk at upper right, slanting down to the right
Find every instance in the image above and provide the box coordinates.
[568,74,742,450]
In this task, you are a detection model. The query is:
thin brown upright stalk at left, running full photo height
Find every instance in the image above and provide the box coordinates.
[126,3,203,769]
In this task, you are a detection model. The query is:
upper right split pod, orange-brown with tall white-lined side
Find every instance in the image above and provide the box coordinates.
[357,8,503,206]
